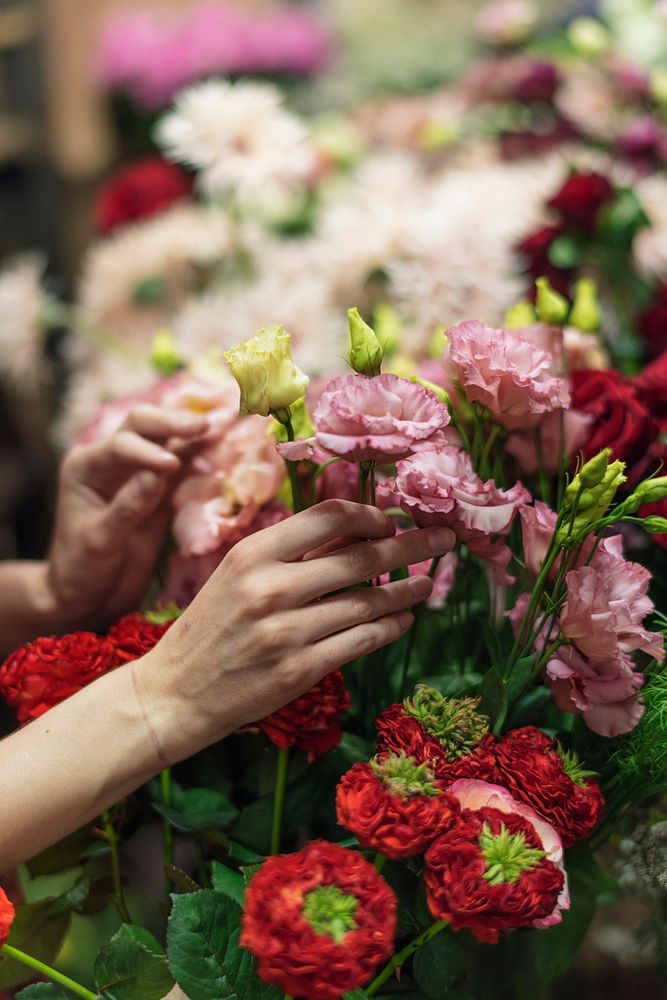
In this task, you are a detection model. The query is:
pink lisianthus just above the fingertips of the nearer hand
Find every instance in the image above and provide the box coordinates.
[378,445,530,584]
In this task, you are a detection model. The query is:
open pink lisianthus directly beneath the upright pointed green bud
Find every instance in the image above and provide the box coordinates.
[313,374,449,462]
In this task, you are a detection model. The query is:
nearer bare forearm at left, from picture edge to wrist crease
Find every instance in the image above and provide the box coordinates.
[0,663,166,871]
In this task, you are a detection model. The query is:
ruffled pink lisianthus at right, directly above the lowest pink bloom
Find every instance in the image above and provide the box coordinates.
[560,535,664,662]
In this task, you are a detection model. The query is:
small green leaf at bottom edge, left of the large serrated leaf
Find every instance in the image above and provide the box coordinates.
[95,920,176,1000]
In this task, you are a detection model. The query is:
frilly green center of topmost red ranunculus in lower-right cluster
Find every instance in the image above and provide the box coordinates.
[403,684,489,759]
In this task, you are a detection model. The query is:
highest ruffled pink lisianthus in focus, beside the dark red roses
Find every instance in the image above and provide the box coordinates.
[444,320,570,430]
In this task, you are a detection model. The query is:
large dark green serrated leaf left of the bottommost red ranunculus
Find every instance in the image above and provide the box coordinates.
[167,890,283,1000]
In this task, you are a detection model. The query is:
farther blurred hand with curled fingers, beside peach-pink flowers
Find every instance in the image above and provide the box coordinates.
[46,405,209,632]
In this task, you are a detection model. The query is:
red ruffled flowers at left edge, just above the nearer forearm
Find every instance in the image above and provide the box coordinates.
[0,613,171,725]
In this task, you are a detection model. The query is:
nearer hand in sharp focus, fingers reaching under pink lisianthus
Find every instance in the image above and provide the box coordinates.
[135,500,455,763]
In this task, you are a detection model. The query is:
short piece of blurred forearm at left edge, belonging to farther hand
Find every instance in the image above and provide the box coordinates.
[0,562,67,658]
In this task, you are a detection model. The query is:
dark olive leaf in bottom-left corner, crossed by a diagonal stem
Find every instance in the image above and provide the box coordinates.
[0,896,70,988]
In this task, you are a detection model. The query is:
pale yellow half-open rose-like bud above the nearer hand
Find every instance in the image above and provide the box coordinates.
[225,326,309,417]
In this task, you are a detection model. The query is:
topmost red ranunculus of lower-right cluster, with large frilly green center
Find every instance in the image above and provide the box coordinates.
[376,685,494,784]
